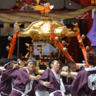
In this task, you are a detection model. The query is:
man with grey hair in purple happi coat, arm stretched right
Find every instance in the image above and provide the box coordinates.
[10,57,41,96]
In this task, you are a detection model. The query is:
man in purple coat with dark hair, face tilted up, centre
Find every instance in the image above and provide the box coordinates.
[35,59,65,96]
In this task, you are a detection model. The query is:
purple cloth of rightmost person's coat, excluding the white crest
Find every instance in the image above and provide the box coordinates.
[70,70,96,96]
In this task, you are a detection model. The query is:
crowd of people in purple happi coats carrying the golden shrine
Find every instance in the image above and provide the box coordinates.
[0,50,96,96]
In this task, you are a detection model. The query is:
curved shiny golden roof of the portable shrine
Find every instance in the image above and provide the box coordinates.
[19,17,74,41]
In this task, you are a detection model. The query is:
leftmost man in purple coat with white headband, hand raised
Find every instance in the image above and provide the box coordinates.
[0,58,19,96]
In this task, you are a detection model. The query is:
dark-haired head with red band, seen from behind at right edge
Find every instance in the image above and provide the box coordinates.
[87,50,96,66]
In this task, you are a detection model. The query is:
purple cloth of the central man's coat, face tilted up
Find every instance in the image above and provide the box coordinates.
[39,69,62,96]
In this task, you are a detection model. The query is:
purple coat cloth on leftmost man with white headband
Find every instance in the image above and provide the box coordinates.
[0,69,19,94]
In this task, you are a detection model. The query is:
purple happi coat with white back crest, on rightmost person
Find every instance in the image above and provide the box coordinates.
[70,67,96,96]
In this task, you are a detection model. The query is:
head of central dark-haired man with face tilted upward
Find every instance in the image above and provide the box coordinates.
[49,59,60,72]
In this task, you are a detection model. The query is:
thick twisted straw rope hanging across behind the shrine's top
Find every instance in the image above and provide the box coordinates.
[0,6,96,23]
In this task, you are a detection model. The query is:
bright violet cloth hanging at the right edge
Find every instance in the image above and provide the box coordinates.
[87,11,96,46]
